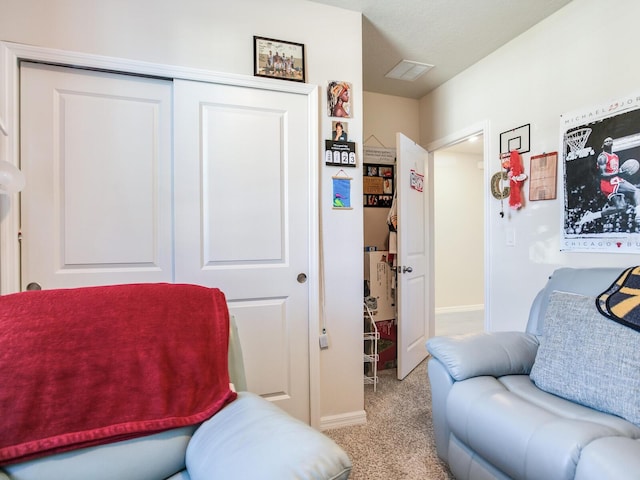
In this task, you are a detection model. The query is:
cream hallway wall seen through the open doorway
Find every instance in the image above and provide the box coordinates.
[433,150,484,311]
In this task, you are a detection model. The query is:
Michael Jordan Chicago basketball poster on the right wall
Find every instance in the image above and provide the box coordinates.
[560,91,640,253]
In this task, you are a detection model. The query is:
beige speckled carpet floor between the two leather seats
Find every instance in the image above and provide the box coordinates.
[324,360,453,480]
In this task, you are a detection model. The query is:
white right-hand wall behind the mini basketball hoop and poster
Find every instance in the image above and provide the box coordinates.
[420,0,640,330]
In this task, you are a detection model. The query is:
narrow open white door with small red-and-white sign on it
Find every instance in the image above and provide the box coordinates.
[396,133,430,379]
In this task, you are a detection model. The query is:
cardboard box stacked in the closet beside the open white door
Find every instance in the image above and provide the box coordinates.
[364,250,396,322]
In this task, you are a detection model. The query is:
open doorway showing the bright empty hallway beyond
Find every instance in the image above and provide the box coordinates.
[433,135,485,335]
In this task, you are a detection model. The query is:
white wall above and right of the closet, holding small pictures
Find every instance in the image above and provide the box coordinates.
[0,0,364,426]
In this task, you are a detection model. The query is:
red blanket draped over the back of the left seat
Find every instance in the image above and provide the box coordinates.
[0,284,235,465]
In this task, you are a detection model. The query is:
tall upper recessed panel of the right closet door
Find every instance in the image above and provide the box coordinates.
[202,105,286,265]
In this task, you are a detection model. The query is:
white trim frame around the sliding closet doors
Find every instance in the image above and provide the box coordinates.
[0,42,320,428]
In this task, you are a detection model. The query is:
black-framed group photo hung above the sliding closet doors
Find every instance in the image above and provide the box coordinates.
[253,35,306,82]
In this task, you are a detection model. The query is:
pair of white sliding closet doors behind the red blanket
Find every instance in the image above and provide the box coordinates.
[20,62,317,422]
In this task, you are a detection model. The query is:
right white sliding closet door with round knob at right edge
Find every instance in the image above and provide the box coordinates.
[175,80,313,422]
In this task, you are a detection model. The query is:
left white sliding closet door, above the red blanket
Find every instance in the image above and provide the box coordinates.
[20,62,173,290]
